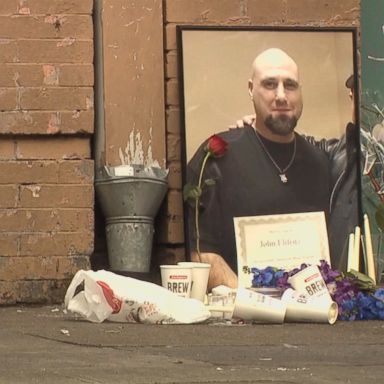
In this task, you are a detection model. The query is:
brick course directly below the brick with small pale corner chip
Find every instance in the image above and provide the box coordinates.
[0,207,94,231]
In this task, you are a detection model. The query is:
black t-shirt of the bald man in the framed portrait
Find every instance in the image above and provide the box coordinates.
[187,126,330,271]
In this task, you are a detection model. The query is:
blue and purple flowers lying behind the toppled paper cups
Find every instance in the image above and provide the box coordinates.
[244,260,384,320]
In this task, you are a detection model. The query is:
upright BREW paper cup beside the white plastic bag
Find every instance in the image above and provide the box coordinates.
[160,265,192,297]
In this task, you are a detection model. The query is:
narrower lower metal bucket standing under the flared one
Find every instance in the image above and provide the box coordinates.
[106,216,154,272]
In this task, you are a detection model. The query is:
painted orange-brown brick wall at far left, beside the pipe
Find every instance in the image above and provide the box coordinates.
[0,0,94,304]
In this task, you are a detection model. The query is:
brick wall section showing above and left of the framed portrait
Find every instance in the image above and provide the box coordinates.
[159,0,360,262]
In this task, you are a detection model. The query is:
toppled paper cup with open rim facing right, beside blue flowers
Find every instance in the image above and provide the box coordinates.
[281,288,338,324]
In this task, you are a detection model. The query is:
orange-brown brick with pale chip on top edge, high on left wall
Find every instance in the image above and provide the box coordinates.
[15,38,93,64]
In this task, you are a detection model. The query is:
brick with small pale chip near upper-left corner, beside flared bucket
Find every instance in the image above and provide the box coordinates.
[19,184,94,208]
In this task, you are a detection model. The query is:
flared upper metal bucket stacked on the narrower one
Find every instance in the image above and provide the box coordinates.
[95,176,168,218]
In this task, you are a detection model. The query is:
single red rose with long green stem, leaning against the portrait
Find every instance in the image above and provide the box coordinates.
[183,135,228,259]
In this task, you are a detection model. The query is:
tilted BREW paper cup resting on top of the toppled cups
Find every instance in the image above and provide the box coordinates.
[288,265,332,303]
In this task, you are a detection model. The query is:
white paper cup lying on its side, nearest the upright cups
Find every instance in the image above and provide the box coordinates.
[233,288,286,324]
